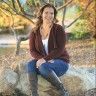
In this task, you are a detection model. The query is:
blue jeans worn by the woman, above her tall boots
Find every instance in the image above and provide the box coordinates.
[27,59,69,77]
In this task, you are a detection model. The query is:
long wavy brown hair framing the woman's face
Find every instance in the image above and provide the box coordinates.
[36,3,58,29]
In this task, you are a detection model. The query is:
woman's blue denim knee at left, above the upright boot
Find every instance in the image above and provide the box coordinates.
[27,60,36,73]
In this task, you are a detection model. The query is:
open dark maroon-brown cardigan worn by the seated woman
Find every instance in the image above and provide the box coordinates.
[29,23,69,63]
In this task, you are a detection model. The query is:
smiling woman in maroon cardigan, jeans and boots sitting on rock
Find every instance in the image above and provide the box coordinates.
[28,4,69,96]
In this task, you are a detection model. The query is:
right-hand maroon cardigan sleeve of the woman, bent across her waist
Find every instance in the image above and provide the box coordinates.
[44,25,66,60]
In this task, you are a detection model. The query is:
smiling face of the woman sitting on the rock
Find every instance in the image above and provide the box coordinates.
[42,7,54,23]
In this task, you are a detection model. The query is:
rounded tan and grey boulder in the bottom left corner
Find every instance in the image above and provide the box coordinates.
[0,67,19,95]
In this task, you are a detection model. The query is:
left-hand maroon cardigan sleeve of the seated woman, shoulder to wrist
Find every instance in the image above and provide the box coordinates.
[29,32,43,60]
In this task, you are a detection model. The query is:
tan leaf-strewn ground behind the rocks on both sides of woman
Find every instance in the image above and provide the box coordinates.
[0,40,95,96]
